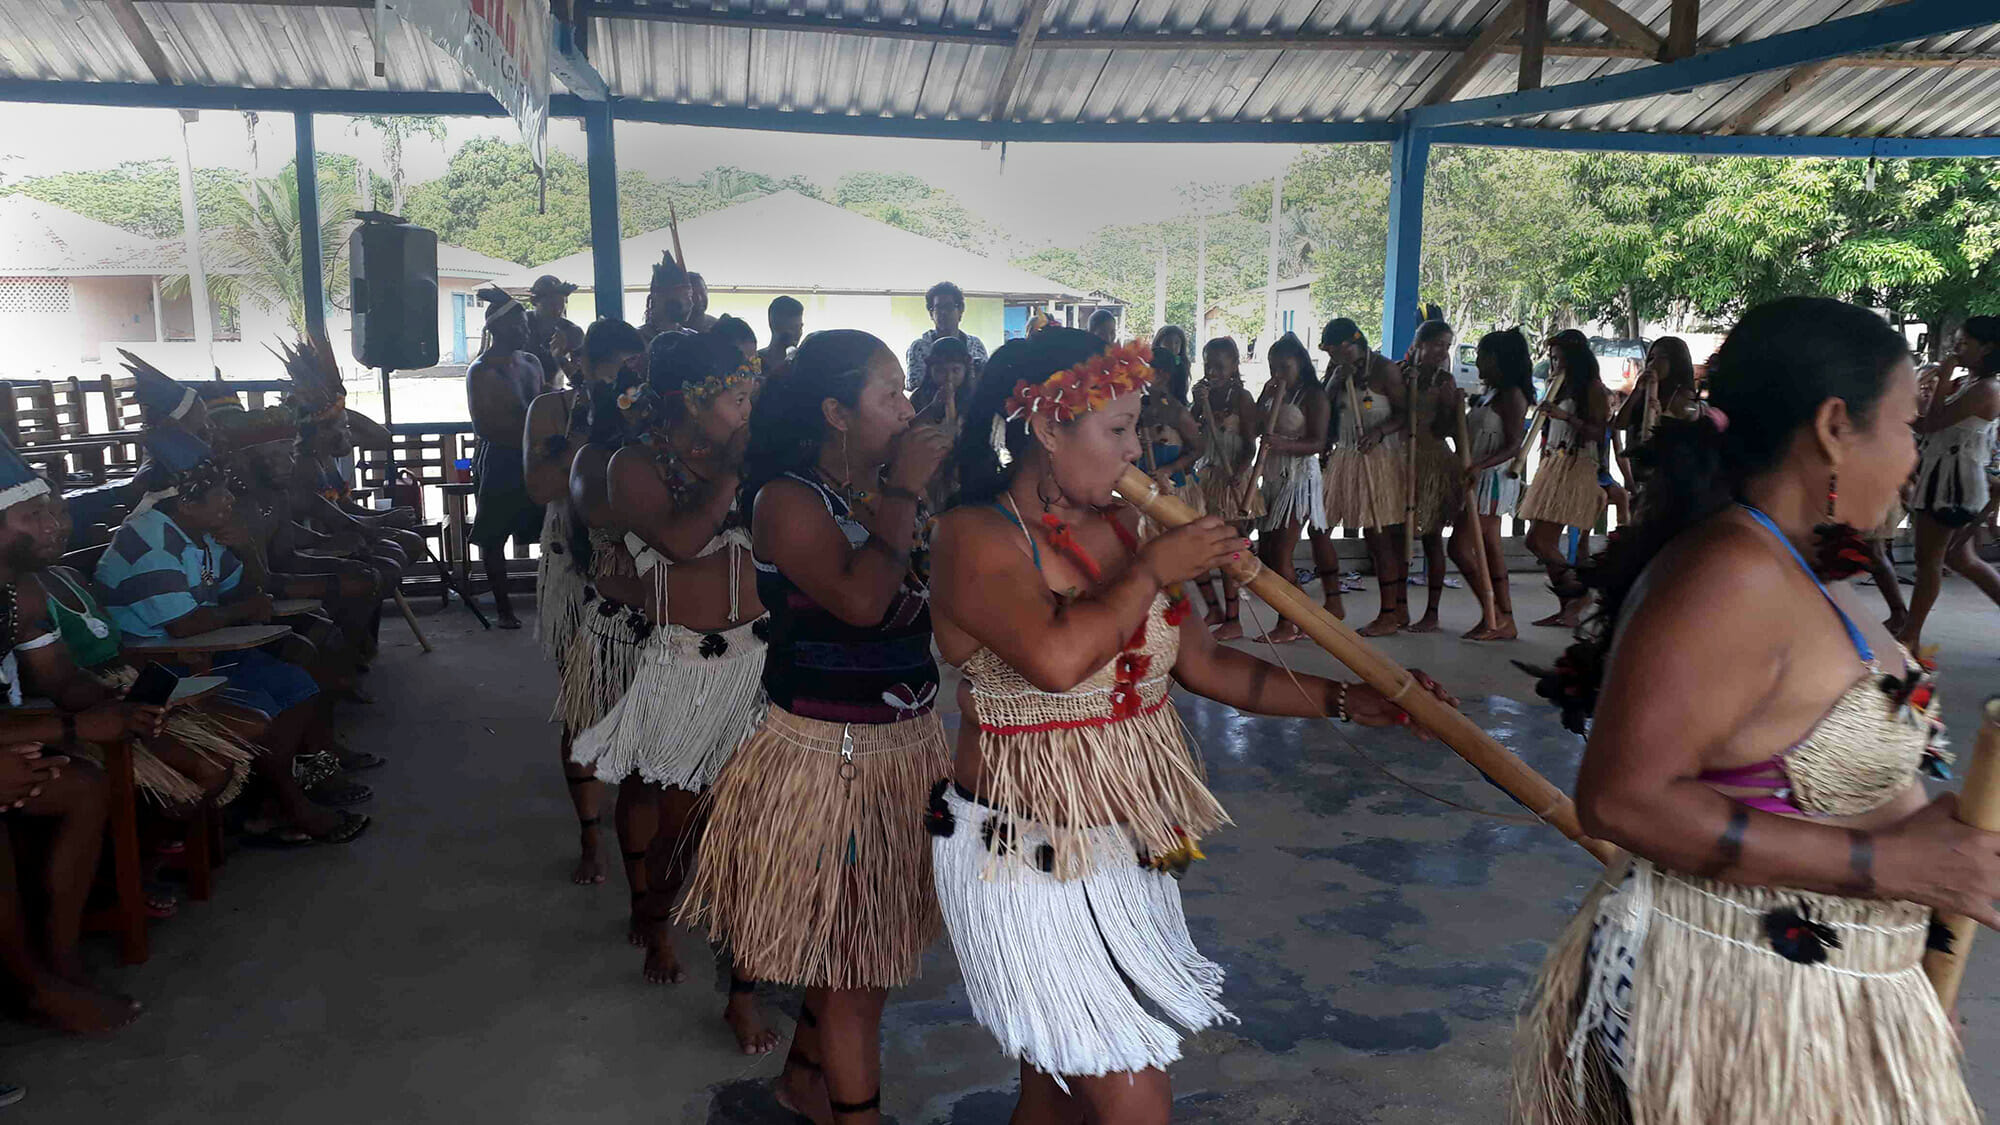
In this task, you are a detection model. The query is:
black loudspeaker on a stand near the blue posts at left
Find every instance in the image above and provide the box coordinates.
[348,210,438,370]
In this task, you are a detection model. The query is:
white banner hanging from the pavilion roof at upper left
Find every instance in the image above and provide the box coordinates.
[394,0,554,166]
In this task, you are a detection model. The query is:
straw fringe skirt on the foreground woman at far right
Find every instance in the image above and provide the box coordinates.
[1510,861,1978,1125]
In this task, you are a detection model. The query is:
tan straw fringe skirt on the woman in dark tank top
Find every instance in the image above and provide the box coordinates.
[680,707,950,989]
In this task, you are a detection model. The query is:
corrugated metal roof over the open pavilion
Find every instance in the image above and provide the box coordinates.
[0,0,2000,136]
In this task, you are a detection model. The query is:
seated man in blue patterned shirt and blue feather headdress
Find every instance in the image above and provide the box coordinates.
[96,428,368,847]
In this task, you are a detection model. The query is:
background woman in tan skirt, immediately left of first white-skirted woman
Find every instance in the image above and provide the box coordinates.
[1194,336,1264,641]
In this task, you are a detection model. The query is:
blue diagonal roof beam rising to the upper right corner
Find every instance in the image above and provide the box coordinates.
[1404,0,2000,128]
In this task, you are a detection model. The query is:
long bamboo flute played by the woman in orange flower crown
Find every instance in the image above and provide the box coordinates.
[1118,466,1618,865]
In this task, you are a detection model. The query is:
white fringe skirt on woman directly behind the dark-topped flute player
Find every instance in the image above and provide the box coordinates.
[570,619,764,793]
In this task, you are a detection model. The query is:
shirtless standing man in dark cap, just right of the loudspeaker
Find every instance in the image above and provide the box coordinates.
[466,288,548,629]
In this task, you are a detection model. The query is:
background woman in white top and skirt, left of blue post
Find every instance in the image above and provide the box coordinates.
[1256,332,1340,645]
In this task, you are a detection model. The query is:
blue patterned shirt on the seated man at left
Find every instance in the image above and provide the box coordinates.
[96,508,244,637]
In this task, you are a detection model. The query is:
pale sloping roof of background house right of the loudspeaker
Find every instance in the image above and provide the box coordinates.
[496,192,1078,300]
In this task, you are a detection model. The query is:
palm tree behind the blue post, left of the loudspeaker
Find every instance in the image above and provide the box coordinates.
[162,166,354,332]
